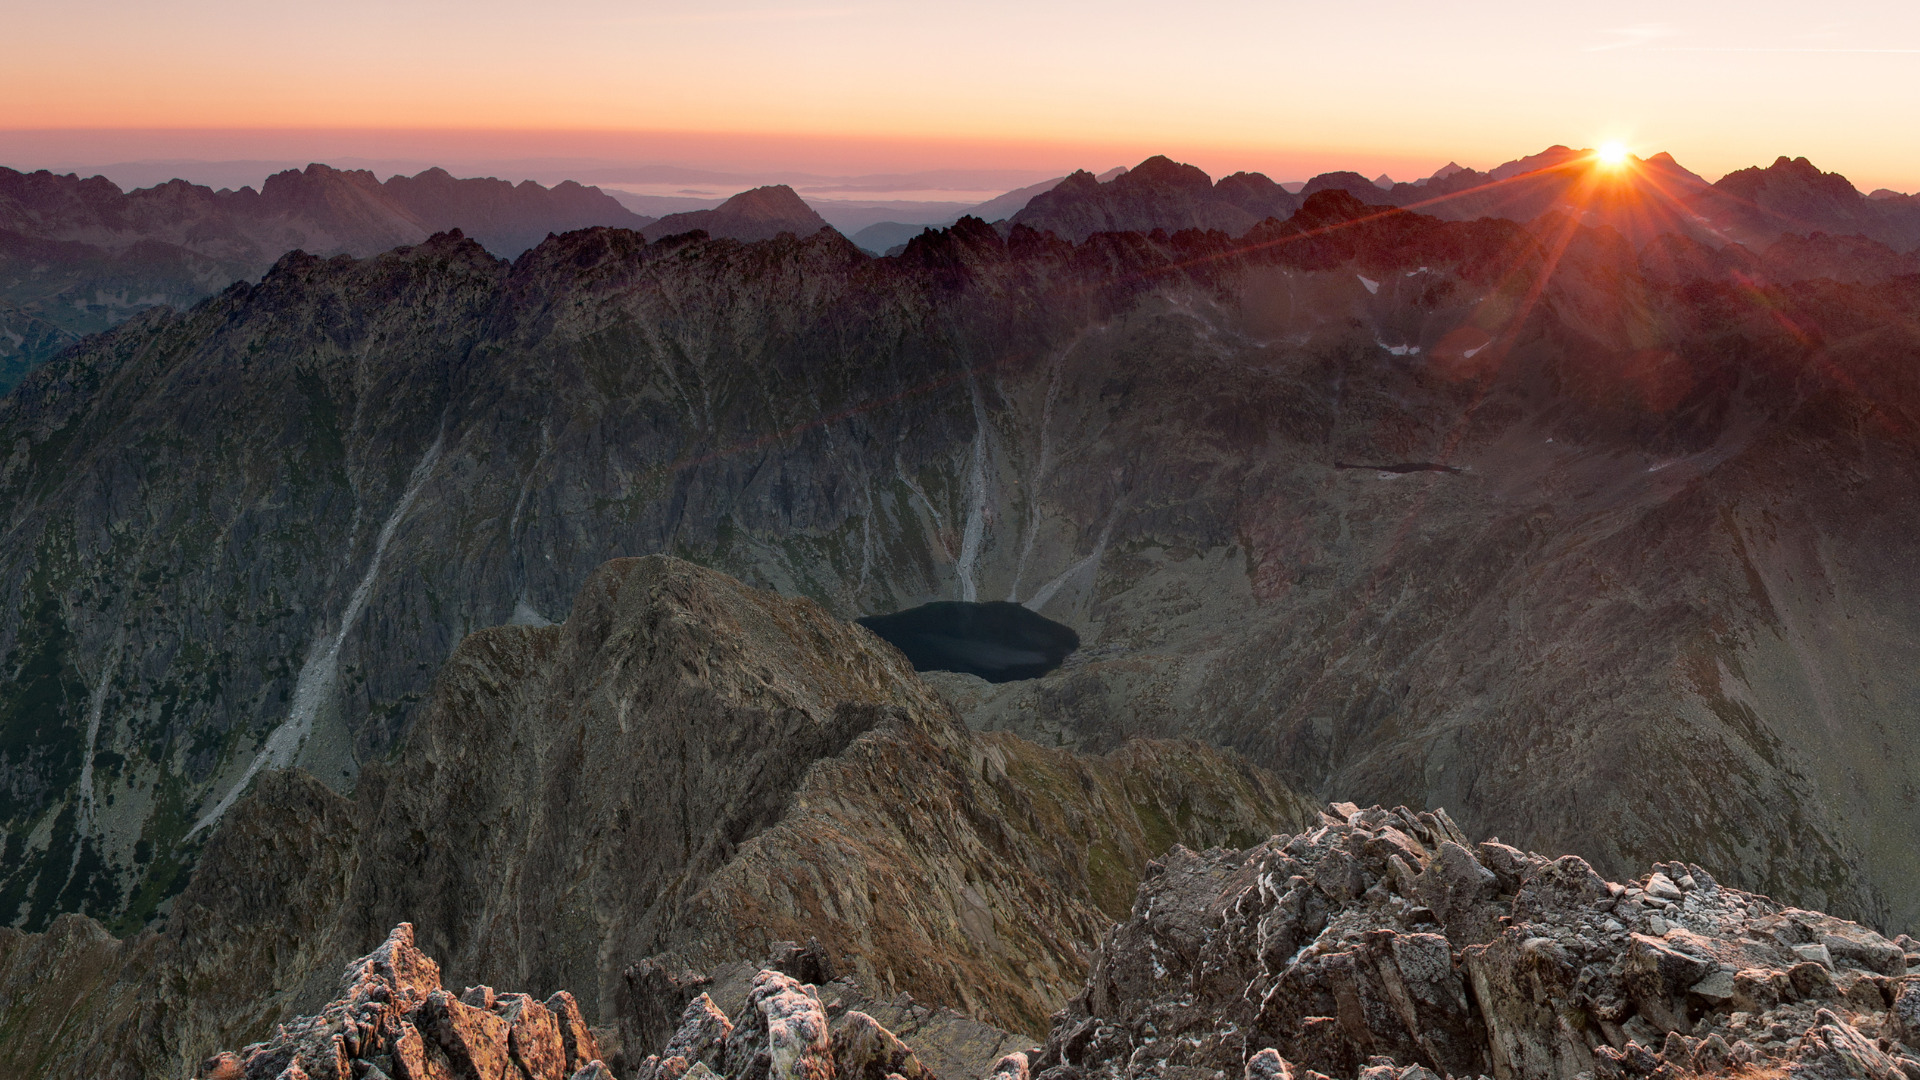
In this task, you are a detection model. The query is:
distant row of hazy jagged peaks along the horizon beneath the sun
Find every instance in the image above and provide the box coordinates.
[0,146,1920,390]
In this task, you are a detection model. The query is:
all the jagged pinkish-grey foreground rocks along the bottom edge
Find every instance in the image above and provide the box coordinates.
[198,803,1920,1080]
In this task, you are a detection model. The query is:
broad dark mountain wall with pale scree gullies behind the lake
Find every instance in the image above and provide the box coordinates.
[0,192,1920,955]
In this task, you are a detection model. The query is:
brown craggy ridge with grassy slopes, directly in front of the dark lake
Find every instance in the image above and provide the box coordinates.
[0,557,1309,1076]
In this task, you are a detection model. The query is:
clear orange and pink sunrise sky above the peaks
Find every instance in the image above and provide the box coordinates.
[0,0,1920,192]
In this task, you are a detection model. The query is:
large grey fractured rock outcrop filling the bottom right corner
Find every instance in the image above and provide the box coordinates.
[1033,803,1920,1080]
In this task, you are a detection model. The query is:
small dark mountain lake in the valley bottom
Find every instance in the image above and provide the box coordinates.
[856,600,1079,682]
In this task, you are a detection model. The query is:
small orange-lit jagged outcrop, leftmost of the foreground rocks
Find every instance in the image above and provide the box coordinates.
[196,922,612,1080]
